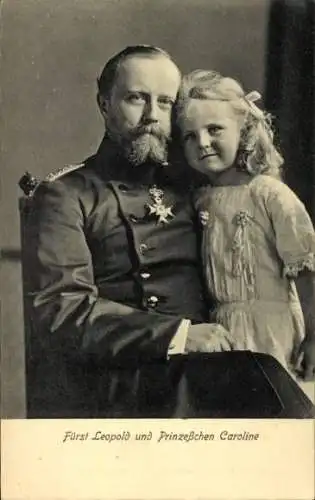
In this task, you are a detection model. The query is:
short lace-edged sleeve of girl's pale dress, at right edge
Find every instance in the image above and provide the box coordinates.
[268,178,315,278]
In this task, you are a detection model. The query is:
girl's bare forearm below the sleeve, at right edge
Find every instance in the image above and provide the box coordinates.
[295,269,315,380]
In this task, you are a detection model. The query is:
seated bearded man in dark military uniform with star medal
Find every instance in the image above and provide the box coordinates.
[28,46,229,417]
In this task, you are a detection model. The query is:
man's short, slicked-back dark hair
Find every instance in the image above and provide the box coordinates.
[97,45,175,97]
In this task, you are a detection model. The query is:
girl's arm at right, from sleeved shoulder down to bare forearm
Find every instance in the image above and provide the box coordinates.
[261,175,315,380]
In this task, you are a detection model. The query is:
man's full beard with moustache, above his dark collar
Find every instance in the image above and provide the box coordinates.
[108,123,169,166]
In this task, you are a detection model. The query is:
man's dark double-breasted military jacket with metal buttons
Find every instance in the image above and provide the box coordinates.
[27,137,204,416]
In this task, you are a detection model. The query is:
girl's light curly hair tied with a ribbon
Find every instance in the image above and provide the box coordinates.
[175,70,283,178]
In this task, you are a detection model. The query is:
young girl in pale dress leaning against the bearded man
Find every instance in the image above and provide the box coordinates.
[177,70,315,379]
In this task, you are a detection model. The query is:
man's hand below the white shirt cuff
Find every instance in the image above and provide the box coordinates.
[185,323,233,353]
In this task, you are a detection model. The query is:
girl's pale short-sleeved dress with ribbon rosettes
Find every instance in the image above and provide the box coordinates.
[196,175,315,368]
